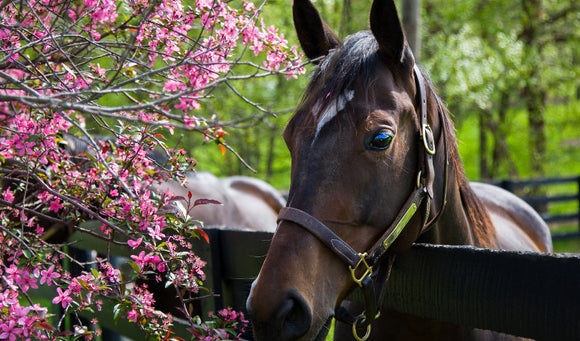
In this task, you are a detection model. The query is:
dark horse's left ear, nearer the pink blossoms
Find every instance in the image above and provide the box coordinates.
[292,0,340,59]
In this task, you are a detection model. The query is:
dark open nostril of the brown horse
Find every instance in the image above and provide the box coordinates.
[276,291,312,340]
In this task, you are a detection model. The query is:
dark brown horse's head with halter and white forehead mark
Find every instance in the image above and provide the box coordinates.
[248,0,462,340]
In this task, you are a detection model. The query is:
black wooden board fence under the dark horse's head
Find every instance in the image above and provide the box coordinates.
[54,229,580,340]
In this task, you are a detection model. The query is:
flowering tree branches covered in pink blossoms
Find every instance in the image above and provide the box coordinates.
[0,0,304,340]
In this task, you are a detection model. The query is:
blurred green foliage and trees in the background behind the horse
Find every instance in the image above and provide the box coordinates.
[163,0,580,189]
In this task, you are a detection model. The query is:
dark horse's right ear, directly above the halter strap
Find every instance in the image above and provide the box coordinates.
[370,0,414,67]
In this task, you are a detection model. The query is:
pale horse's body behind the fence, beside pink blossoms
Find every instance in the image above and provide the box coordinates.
[154,172,286,232]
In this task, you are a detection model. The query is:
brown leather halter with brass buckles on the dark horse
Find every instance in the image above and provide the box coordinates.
[278,65,449,341]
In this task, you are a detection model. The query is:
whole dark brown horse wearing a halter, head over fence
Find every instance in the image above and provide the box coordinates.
[246,0,552,340]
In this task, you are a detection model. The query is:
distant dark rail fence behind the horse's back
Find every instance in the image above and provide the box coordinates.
[491,176,580,239]
